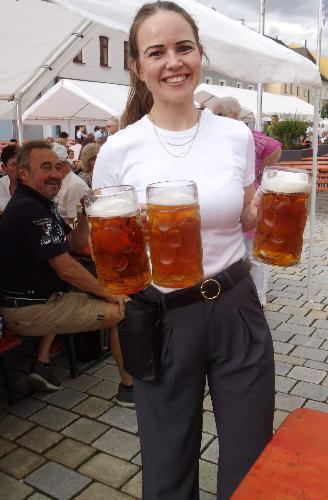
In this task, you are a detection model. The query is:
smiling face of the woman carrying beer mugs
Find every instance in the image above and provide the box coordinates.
[132,10,201,105]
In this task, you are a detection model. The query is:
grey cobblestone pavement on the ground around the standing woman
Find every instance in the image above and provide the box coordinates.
[0,193,328,500]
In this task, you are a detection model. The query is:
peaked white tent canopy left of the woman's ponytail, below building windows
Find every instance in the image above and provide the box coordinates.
[23,79,129,125]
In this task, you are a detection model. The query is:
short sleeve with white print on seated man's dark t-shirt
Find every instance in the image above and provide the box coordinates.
[24,209,70,262]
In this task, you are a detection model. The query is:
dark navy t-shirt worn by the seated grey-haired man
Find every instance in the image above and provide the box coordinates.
[0,184,71,298]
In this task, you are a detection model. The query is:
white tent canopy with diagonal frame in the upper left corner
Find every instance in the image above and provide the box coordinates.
[0,0,93,111]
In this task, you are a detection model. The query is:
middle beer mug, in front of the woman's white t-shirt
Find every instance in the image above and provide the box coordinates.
[147,181,204,288]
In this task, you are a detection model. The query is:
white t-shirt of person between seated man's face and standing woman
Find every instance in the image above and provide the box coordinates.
[55,172,90,219]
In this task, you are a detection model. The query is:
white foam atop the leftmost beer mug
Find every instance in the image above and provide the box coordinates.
[86,194,139,217]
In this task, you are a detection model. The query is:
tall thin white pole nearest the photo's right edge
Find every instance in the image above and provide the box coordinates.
[307,0,323,302]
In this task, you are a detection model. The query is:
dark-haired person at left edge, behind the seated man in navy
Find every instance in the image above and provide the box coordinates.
[0,145,18,215]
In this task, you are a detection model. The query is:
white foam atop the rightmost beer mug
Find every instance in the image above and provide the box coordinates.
[261,170,311,194]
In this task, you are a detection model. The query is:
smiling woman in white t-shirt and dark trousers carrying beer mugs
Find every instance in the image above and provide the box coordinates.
[93,1,274,500]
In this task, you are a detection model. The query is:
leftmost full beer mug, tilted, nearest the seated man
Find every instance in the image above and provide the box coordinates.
[84,186,151,295]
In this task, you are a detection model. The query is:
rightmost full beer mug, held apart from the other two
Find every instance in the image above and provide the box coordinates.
[253,166,311,267]
